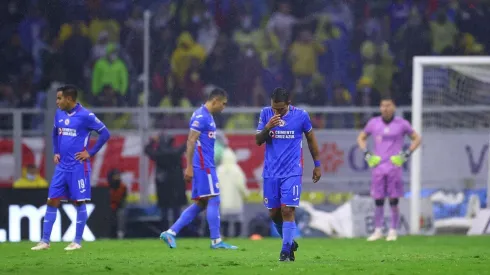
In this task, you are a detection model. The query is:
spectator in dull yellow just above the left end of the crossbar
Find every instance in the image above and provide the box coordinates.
[430,10,458,54]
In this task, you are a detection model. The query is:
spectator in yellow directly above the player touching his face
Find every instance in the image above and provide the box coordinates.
[289,29,325,78]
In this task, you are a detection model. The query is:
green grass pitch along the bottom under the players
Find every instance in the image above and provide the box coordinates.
[0,236,490,275]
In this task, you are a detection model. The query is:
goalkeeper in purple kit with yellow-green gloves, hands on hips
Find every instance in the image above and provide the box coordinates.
[357,98,421,241]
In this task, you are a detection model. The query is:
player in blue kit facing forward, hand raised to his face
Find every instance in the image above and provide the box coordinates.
[255,88,321,261]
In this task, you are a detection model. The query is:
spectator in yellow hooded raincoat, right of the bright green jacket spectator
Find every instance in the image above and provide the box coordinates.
[170,32,206,83]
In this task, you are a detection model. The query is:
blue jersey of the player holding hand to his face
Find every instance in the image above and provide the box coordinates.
[257,106,312,178]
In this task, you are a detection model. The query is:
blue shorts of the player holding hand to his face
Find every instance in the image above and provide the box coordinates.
[264,176,302,209]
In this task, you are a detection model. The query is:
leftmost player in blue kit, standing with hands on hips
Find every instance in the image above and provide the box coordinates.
[31,85,110,250]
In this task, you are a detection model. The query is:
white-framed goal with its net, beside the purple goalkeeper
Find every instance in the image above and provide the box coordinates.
[410,57,490,234]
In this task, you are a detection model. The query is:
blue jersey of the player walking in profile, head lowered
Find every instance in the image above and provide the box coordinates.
[189,105,216,168]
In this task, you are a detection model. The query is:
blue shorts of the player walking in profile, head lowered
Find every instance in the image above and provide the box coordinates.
[192,167,219,200]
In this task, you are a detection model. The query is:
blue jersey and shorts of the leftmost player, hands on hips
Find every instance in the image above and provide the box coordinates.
[48,104,110,201]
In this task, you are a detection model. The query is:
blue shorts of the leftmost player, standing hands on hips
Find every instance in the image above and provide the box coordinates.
[48,168,91,201]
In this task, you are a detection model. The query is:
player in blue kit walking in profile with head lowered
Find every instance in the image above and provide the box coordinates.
[160,89,237,249]
